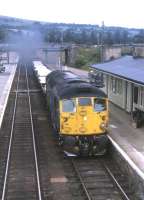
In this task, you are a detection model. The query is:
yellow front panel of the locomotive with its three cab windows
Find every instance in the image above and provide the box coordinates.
[60,97,108,135]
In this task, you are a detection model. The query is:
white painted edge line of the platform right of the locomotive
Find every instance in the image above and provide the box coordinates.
[108,135,144,180]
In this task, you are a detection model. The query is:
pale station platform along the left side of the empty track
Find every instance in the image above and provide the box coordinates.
[0,64,17,127]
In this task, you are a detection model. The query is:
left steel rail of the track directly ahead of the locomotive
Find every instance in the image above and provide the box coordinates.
[71,159,92,200]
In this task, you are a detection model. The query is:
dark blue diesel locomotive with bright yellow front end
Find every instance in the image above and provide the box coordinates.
[46,70,109,155]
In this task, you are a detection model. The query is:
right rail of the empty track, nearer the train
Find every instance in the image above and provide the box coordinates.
[25,66,42,200]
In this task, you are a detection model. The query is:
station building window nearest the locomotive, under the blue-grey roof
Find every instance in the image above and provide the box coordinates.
[111,77,122,94]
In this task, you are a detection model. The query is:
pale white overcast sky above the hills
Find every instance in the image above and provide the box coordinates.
[0,0,144,28]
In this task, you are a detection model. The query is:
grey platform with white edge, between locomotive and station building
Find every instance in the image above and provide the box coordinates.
[109,103,144,180]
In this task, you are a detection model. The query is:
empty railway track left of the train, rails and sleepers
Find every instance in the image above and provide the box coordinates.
[0,62,42,200]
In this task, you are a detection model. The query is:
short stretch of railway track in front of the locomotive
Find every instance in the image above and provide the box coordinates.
[62,158,132,200]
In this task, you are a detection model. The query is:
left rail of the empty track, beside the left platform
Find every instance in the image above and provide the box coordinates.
[1,68,20,200]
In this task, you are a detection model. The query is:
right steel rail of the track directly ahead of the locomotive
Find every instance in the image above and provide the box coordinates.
[104,164,130,200]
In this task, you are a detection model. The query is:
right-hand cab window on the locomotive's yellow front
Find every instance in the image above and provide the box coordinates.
[94,98,106,112]
